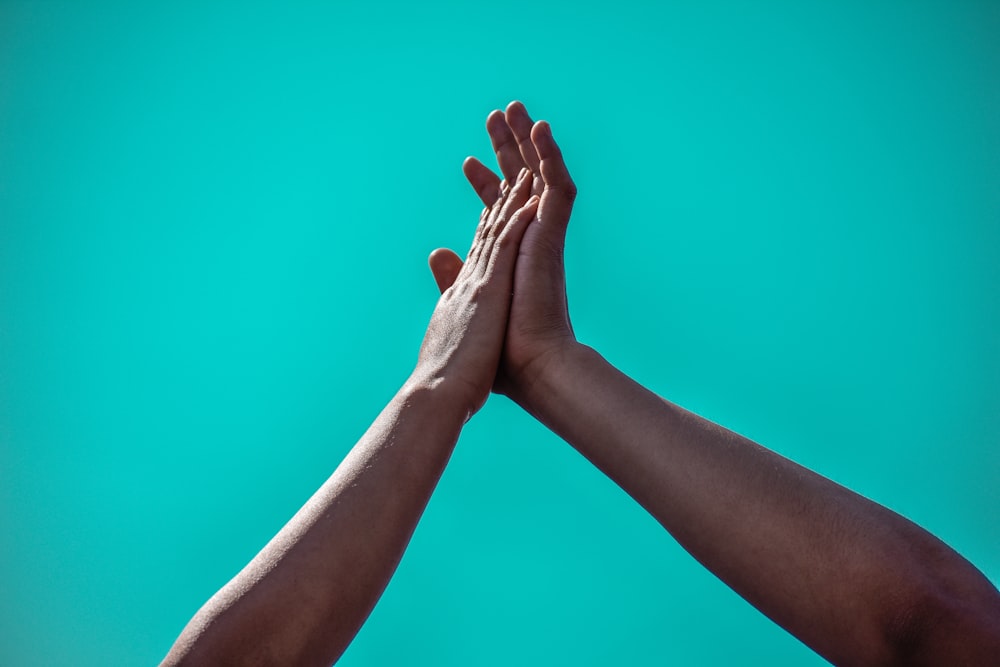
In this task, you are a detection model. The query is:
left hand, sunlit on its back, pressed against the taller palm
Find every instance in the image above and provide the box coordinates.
[414,168,539,418]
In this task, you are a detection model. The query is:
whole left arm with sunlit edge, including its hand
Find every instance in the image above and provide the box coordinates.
[163,170,538,665]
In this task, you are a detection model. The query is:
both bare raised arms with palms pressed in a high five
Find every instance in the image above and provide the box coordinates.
[163,102,1000,665]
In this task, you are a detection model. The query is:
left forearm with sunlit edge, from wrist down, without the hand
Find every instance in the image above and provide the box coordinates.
[165,381,468,665]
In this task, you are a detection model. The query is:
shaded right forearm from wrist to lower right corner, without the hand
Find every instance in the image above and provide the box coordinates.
[513,346,1000,664]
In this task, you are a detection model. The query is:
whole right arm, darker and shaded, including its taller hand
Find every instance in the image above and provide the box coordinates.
[458,102,1000,664]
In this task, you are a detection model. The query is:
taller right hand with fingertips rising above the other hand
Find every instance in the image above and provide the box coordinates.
[430,102,576,398]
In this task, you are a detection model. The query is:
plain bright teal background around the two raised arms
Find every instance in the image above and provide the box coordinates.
[0,0,1000,666]
